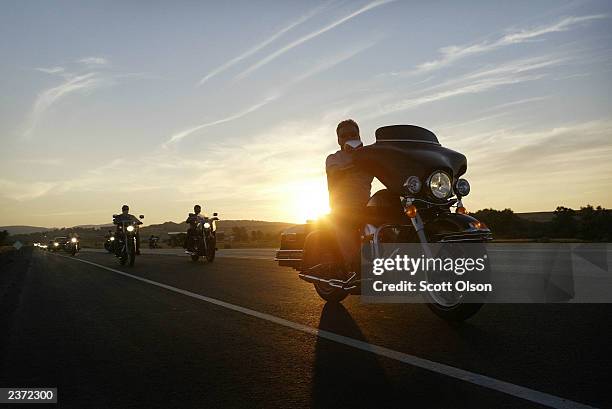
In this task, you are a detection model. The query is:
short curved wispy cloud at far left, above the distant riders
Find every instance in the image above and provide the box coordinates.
[24,72,104,136]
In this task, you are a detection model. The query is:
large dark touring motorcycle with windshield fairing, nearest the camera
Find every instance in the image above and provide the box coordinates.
[276,125,492,321]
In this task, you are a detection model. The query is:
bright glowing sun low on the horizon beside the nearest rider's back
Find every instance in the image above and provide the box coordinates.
[292,178,329,223]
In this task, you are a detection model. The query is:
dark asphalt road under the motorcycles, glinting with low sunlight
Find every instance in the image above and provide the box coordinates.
[0,248,612,408]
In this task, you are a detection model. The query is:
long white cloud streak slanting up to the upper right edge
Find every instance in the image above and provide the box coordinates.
[412,14,608,73]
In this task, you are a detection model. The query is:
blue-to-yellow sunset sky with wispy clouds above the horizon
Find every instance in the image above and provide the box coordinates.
[0,0,612,227]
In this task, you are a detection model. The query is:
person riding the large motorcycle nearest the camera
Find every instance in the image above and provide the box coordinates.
[325,119,373,272]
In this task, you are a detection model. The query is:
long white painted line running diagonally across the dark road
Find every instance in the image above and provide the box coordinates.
[56,254,594,409]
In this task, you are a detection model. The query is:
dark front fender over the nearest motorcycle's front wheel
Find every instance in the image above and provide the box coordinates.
[425,213,493,243]
